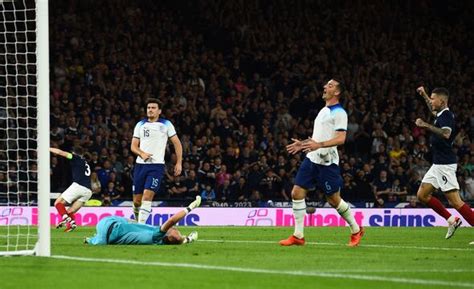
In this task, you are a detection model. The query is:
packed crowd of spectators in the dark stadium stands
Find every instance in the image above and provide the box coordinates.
[46,0,474,207]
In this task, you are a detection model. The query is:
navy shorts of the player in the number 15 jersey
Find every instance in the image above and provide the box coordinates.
[133,164,165,194]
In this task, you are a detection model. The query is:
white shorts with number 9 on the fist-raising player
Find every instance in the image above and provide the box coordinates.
[421,164,459,192]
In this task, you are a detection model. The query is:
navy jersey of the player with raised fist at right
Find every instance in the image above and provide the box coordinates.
[430,108,457,165]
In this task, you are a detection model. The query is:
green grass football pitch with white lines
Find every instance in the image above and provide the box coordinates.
[0,227,474,289]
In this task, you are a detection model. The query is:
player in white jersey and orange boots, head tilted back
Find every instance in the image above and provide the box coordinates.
[280,79,364,247]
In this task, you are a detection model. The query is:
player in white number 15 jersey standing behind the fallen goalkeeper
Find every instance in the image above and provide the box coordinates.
[131,98,183,224]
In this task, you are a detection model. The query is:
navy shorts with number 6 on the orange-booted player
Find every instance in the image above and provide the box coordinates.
[295,158,343,196]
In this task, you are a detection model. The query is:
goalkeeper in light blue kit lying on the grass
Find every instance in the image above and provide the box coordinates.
[85,196,201,245]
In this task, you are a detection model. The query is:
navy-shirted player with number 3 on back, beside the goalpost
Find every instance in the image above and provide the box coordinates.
[49,147,92,232]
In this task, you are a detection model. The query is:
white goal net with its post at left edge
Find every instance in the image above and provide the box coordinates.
[0,0,50,256]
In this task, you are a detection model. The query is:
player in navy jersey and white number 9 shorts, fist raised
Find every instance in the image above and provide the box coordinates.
[416,86,474,239]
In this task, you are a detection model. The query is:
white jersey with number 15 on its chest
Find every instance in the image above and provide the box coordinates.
[133,118,176,164]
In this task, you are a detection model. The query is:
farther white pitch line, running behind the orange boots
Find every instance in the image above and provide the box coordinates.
[198,239,474,252]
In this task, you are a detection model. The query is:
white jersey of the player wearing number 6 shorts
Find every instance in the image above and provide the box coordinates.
[306,103,347,166]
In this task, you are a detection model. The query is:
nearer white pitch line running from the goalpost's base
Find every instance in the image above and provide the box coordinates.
[51,255,474,288]
